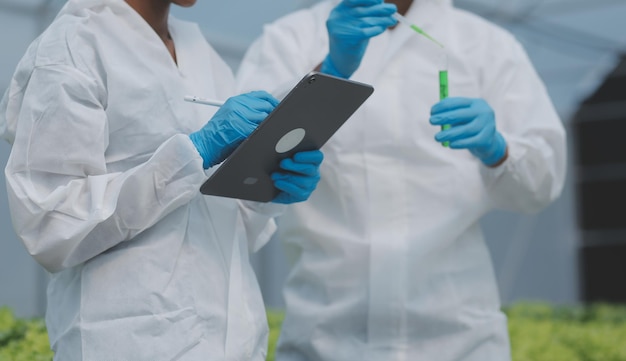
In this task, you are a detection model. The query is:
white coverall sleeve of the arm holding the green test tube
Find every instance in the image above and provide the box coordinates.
[482,41,566,213]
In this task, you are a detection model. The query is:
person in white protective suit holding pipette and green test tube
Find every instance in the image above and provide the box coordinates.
[237,0,566,361]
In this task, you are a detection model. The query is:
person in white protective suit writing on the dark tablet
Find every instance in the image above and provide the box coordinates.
[0,0,322,361]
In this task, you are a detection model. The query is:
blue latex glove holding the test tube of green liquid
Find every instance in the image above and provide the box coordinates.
[430,98,507,166]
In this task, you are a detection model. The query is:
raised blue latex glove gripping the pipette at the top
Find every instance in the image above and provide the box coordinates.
[320,0,397,78]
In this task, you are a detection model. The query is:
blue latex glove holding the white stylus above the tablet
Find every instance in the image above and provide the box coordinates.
[189,91,278,169]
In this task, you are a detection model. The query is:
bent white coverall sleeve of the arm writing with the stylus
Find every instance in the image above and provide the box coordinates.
[5,65,205,272]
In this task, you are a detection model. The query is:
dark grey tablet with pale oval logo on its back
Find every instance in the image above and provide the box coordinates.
[200,72,374,202]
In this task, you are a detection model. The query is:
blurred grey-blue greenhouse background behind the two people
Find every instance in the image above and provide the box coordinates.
[0,0,626,317]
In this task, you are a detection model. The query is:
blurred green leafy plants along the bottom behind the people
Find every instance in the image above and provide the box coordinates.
[0,303,626,361]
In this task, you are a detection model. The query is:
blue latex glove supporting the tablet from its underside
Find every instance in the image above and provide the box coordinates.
[271,150,324,204]
